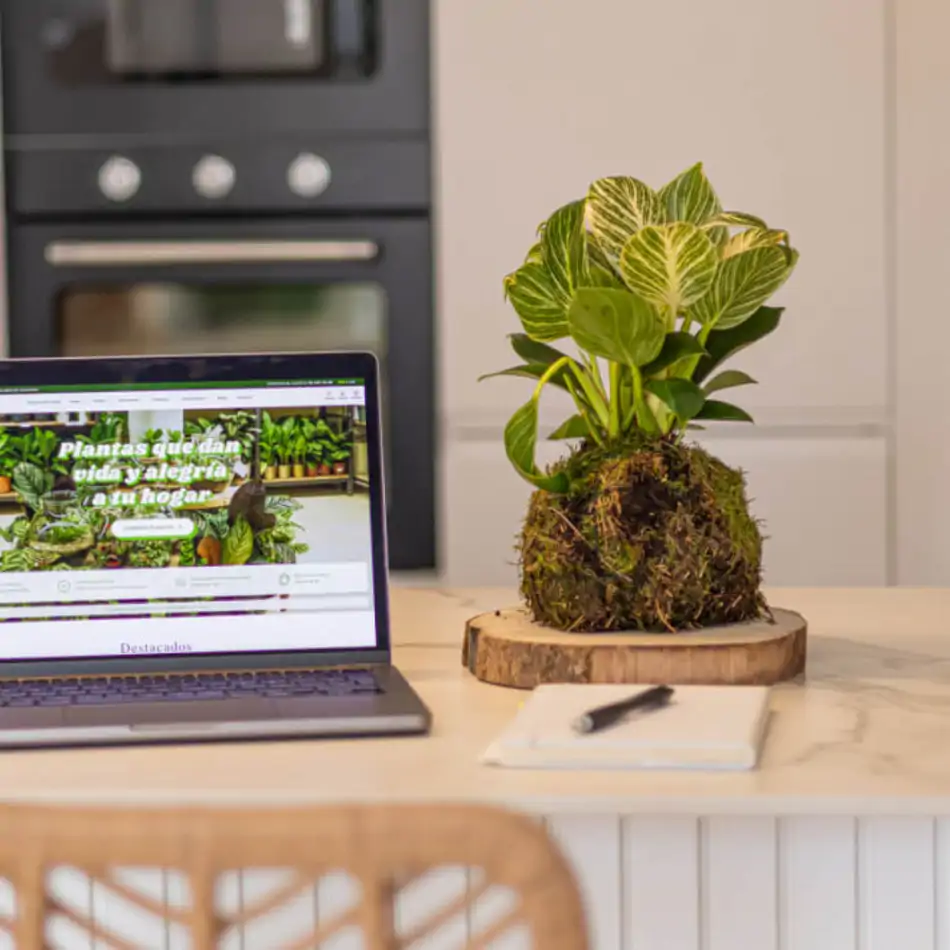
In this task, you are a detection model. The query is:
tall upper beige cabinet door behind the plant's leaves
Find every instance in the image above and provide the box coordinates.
[434,0,888,425]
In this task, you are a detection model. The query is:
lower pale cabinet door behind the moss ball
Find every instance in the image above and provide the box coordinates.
[442,436,887,586]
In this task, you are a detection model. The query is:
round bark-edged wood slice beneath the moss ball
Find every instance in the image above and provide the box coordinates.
[462,607,808,689]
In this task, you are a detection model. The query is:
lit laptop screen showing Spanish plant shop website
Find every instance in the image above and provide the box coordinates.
[0,378,376,660]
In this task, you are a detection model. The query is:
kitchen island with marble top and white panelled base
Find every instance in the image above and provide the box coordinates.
[0,588,950,950]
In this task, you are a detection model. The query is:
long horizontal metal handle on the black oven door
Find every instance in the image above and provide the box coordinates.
[45,241,379,267]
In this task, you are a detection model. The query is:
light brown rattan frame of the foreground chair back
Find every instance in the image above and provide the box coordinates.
[0,805,588,950]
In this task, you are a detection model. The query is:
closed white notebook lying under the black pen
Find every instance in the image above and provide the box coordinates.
[482,684,769,769]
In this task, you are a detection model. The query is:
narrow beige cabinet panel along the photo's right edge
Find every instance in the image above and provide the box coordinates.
[894,0,950,587]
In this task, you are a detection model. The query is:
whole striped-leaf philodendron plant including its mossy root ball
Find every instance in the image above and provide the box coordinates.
[491,165,798,632]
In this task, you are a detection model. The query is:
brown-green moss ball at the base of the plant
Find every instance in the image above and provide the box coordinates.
[519,439,767,632]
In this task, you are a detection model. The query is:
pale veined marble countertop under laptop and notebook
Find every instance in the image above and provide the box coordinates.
[0,587,950,814]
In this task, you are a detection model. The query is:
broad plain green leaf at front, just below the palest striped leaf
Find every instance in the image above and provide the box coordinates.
[568,287,666,367]
